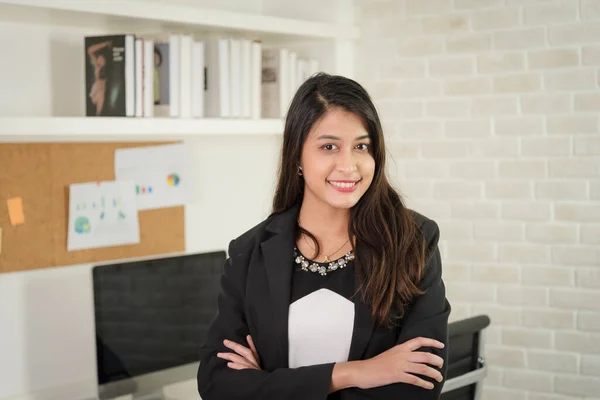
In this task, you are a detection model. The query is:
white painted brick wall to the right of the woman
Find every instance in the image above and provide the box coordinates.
[357,0,600,400]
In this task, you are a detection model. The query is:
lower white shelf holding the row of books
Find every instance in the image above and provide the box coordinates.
[0,117,284,143]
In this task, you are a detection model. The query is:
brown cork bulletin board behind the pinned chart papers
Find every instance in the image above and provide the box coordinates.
[0,142,185,273]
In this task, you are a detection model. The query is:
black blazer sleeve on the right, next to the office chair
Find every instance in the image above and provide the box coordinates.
[342,220,450,400]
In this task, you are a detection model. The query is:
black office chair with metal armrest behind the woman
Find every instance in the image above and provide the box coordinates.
[440,315,490,400]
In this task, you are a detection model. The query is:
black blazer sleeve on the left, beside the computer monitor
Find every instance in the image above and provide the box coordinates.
[197,241,334,400]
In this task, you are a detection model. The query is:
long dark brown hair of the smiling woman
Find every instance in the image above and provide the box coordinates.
[272,73,425,328]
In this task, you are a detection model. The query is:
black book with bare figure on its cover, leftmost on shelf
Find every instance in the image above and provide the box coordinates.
[84,34,136,117]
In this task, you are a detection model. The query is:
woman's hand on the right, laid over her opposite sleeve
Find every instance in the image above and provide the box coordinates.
[355,337,444,389]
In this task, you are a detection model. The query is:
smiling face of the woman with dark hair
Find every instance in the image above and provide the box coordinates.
[301,107,375,209]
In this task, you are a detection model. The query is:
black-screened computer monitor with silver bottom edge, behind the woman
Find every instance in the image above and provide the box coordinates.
[92,251,226,399]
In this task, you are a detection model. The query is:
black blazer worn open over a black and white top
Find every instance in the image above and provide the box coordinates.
[198,207,450,400]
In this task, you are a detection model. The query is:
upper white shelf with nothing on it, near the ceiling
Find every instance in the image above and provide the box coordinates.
[0,0,359,39]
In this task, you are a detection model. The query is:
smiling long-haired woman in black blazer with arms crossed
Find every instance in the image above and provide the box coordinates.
[198,74,450,400]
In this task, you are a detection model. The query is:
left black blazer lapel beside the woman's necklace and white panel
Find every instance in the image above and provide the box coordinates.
[260,207,298,366]
